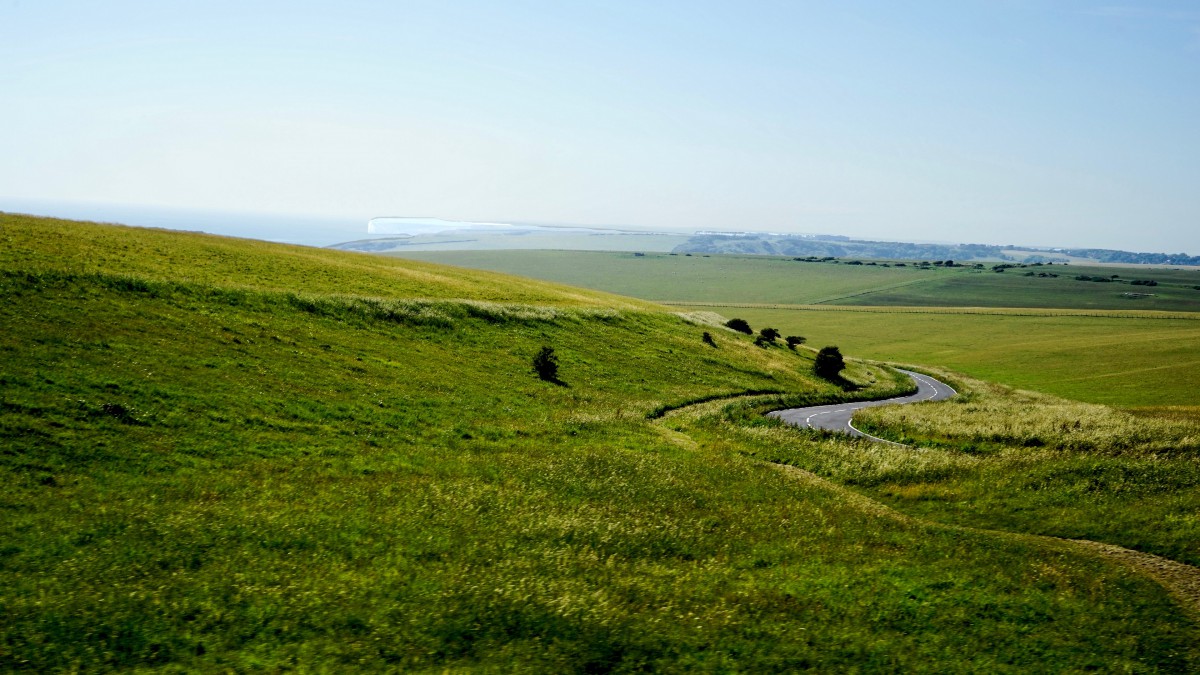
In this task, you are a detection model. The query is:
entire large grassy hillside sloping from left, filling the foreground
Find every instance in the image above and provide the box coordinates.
[7,215,1200,671]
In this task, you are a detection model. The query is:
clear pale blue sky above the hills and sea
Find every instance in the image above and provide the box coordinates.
[0,0,1200,255]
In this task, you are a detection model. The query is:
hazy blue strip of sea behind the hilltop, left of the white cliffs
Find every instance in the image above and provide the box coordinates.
[0,197,370,246]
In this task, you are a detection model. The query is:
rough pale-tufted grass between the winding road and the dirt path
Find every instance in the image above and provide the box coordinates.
[739,367,1200,566]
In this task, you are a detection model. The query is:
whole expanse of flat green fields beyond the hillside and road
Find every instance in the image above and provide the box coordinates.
[400,251,1200,406]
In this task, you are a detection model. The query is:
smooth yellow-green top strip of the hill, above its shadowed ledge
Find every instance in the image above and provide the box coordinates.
[0,213,652,309]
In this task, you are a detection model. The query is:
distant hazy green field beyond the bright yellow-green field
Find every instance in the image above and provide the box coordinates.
[407,251,1200,312]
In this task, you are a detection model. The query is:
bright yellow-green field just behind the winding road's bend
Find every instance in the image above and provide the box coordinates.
[689,306,1200,407]
